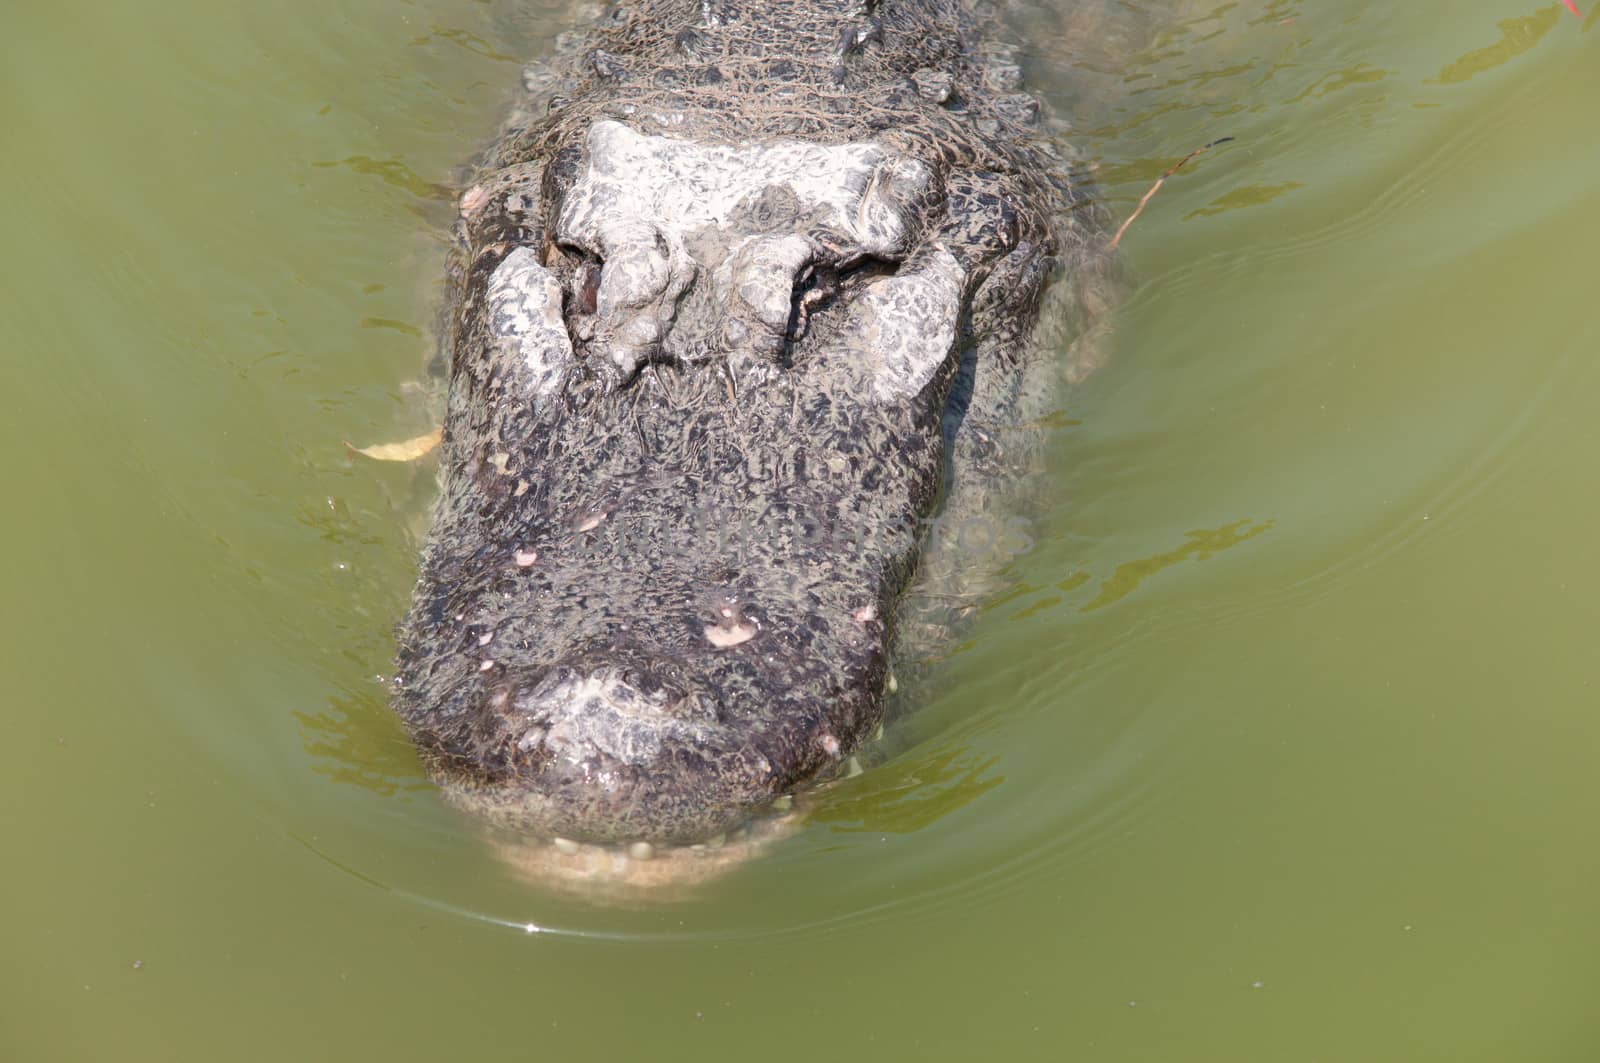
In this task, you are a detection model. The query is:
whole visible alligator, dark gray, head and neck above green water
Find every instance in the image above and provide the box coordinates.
[394,0,1109,847]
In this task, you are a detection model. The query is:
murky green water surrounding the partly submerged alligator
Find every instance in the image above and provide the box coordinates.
[0,0,1600,1061]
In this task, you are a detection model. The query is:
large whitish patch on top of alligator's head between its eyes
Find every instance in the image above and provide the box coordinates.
[555,122,934,373]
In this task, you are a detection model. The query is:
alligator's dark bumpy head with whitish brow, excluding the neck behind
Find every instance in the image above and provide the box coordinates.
[395,101,1075,877]
